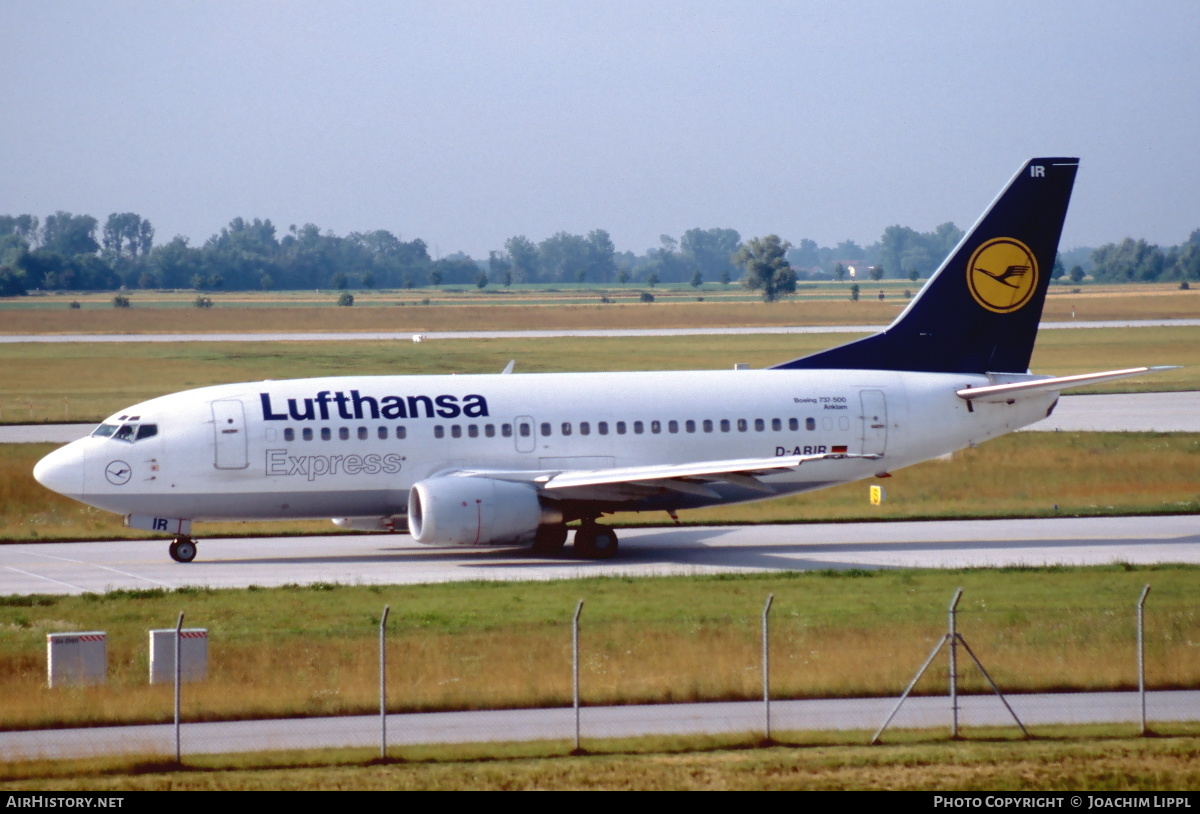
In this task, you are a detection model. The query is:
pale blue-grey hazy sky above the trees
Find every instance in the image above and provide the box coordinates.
[0,0,1200,257]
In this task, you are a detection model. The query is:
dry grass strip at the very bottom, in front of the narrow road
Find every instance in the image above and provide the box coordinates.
[7,725,1200,792]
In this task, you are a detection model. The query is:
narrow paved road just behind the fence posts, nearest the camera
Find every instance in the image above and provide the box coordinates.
[0,687,1200,761]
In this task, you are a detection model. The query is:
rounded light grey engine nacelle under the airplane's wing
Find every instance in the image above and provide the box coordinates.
[408,477,563,545]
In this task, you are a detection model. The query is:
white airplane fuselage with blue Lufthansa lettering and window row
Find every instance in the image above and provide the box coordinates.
[36,370,1057,520]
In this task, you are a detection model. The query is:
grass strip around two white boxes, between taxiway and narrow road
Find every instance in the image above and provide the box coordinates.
[0,565,1200,729]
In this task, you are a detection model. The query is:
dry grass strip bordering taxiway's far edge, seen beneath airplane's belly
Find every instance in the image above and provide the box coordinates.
[0,432,1200,541]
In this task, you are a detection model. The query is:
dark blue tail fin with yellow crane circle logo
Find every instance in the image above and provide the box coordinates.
[775,158,1079,373]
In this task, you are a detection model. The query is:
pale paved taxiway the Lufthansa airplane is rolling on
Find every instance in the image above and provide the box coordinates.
[0,515,1200,595]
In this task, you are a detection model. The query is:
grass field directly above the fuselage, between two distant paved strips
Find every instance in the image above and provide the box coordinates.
[0,328,1200,424]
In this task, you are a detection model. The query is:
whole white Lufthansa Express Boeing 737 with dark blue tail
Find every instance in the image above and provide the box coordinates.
[34,157,1157,563]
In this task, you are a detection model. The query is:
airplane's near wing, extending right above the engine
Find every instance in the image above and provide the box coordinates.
[456,453,880,499]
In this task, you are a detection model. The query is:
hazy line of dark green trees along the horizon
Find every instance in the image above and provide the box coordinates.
[0,211,1200,300]
